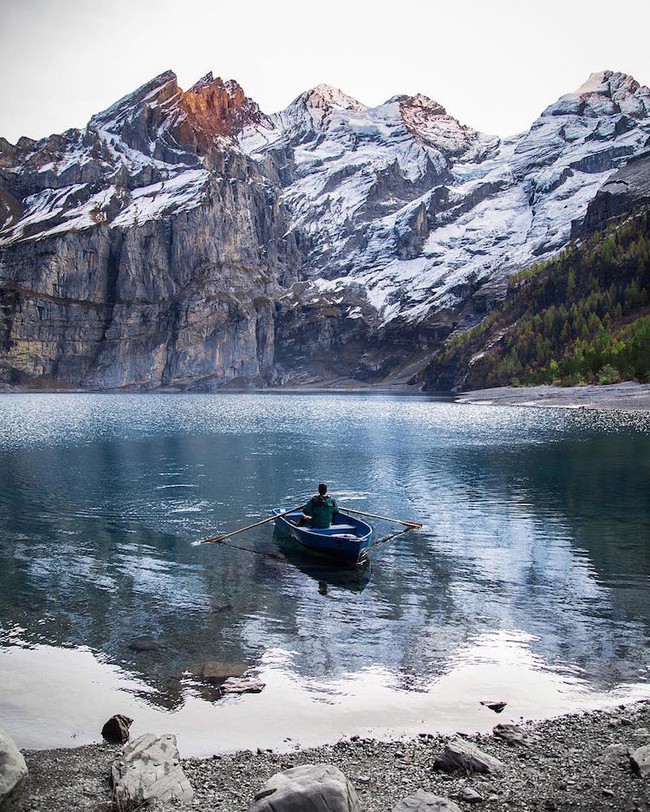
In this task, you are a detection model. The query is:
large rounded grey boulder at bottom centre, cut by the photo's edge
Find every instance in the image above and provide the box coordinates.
[248,764,361,812]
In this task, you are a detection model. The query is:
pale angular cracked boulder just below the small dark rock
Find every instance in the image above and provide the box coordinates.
[111,733,194,809]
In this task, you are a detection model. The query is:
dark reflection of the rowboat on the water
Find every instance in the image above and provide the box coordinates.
[273,527,371,595]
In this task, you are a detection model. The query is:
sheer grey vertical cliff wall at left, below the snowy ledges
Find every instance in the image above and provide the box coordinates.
[0,166,296,389]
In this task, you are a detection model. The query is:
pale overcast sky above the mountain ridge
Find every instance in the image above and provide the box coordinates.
[0,0,650,143]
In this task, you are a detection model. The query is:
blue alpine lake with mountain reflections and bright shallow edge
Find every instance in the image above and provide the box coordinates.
[0,393,650,756]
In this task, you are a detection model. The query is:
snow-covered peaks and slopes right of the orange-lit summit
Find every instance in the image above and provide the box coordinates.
[240,72,650,322]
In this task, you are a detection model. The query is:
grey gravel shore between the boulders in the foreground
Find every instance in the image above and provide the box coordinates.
[17,701,650,812]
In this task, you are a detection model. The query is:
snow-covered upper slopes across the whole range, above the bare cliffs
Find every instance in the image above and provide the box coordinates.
[0,66,650,324]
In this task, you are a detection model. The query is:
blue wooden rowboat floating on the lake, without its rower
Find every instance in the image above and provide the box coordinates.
[273,508,372,564]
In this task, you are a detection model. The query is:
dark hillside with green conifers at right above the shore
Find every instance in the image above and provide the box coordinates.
[426,209,650,389]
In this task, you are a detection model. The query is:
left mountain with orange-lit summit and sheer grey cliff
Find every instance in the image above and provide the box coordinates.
[0,72,297,390]
